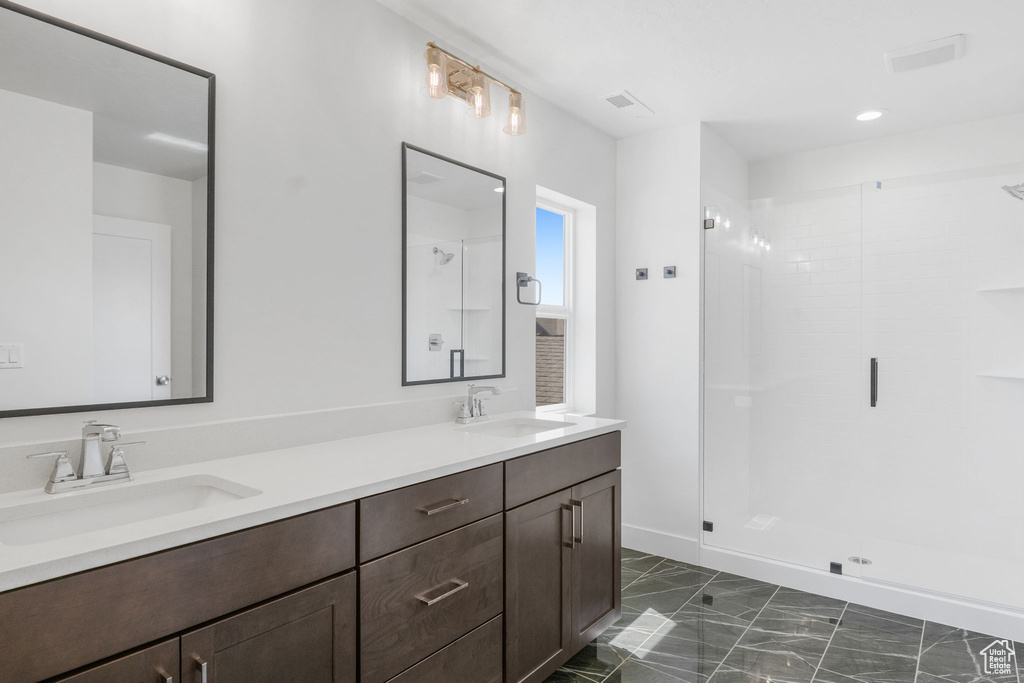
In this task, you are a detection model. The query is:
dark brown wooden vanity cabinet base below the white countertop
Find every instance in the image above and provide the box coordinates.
[0,432,621,683]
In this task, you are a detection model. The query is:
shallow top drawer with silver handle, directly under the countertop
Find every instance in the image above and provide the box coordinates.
[359,463,504,562]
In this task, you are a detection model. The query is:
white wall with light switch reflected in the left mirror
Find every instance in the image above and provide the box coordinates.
[0,90,92,411]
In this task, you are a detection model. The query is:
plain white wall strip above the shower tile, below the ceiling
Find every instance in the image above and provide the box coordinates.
[751,114,1024,198]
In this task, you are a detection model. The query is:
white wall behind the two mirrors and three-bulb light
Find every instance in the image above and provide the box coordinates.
[0,0,615,458]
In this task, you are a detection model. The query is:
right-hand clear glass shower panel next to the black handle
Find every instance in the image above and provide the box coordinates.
[862,166,1024,608]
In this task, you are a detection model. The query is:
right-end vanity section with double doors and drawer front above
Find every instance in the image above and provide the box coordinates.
[505,432,622,683]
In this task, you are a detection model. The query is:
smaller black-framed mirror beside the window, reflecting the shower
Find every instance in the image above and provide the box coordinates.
[401,142,506,385]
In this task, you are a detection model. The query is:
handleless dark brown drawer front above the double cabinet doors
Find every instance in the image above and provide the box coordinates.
[505,431,623,510]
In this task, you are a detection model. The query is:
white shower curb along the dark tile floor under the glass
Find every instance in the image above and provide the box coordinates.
[700,540,1024,642]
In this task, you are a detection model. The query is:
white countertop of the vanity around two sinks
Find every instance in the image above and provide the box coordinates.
[0,412,626,592]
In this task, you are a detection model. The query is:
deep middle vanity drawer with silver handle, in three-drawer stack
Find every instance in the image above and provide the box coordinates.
[359,514,504,683]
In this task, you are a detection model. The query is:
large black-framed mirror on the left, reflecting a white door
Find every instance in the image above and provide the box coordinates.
[0,0,215,418]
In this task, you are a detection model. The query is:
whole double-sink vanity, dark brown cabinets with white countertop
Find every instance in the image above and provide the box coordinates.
[0,413,624,683]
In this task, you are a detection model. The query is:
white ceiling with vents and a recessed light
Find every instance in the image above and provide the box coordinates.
[378,0,1024,160]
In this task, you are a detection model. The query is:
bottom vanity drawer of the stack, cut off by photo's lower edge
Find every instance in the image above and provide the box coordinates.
[389,616,502,683]
